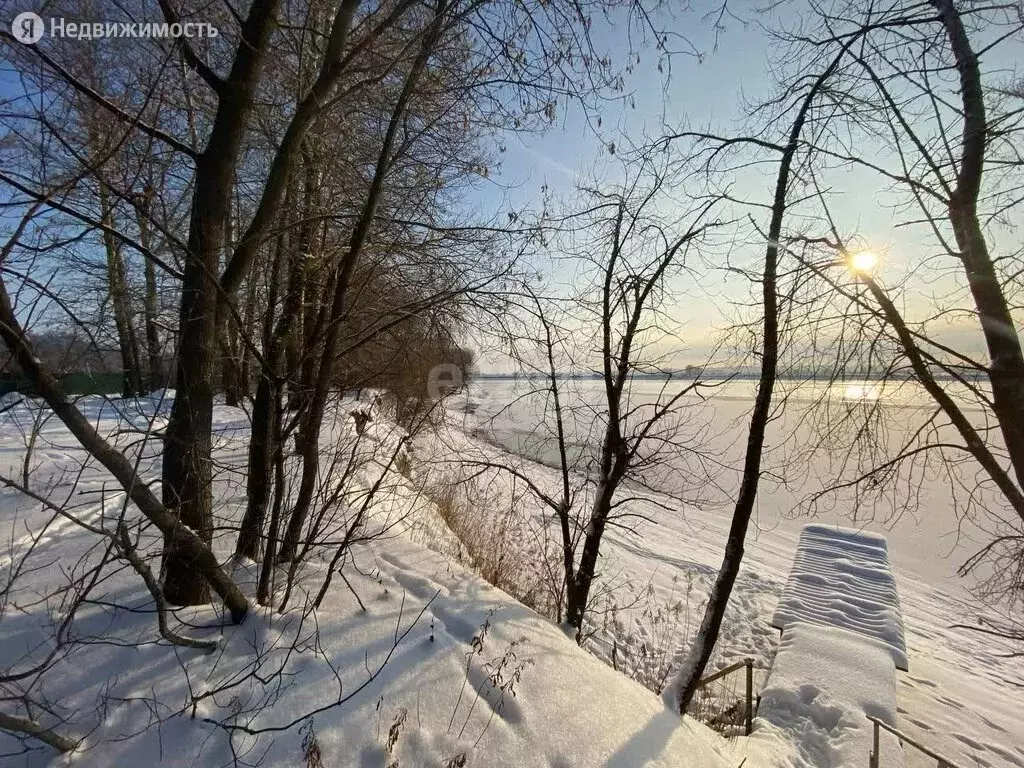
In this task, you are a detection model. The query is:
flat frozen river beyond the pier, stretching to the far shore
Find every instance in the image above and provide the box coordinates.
[462,379,998,581]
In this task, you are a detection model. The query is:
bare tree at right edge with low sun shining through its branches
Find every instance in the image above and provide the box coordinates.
[753,0,1024,600]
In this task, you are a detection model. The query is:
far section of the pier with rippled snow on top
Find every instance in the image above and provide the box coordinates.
[772,525,907,671]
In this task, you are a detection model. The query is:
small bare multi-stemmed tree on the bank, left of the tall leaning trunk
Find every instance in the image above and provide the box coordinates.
[436,157,723,642]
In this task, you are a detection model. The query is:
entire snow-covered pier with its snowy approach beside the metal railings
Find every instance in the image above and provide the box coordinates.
[755,525,907,768]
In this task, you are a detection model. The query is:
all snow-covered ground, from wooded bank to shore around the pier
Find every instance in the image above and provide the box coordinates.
[0,382,1024,768]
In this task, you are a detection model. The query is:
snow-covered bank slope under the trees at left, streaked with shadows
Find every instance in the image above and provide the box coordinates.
[0,398,738,768]
